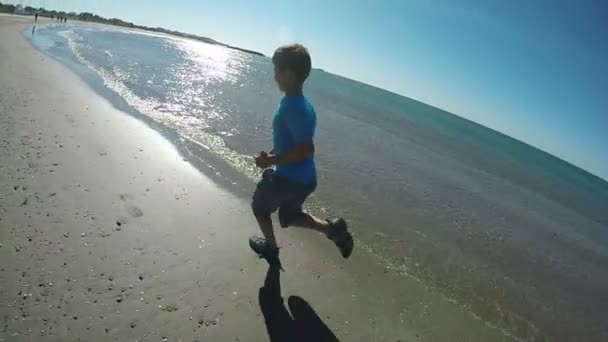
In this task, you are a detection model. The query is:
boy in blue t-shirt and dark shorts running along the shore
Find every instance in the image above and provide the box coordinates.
[249,44,353,263]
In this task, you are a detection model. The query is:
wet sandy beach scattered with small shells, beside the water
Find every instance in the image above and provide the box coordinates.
[0,15,512,342]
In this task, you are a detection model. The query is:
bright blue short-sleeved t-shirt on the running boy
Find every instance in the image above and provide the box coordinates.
[272,95,317,183]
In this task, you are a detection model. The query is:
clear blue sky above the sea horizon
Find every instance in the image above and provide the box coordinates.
[8,0,608,179]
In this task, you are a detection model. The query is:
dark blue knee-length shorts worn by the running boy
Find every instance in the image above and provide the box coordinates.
[251,170,317,228]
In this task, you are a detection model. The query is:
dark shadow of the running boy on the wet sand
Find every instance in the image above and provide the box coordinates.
[259,265,339,342]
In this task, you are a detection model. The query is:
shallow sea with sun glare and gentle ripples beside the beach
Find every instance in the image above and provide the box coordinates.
[24,25,608,341]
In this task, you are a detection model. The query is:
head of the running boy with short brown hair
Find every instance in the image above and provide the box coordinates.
[272,44,311,93]
